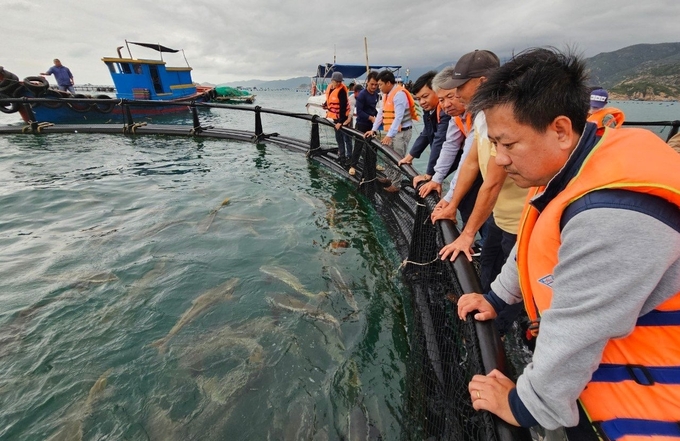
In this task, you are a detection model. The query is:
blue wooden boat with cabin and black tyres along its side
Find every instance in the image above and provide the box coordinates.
[6,40,216,124]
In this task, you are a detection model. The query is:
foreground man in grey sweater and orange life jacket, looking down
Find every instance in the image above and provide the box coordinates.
[458,49,680,441]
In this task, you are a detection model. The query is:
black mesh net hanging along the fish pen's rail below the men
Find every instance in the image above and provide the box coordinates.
[312,131,531,441]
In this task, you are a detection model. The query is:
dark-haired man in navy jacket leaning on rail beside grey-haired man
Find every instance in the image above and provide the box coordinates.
[399,70,451,188]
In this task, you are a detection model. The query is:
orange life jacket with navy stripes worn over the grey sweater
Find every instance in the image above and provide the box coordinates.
[517,125,680,441]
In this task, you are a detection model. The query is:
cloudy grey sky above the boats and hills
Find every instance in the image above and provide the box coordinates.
[5,0,680,84]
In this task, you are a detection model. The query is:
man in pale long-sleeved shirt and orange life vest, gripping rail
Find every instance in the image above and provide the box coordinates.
[364,70,418,193]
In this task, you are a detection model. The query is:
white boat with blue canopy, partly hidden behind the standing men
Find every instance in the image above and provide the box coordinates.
[306,63,401,118]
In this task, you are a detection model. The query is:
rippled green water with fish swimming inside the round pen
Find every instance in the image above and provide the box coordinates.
[0,91,407,440]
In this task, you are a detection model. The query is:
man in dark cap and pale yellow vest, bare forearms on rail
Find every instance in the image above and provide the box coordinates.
[432,51,527,310]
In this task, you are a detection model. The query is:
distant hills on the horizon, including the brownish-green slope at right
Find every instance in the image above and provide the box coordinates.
[216,43,680,101]
